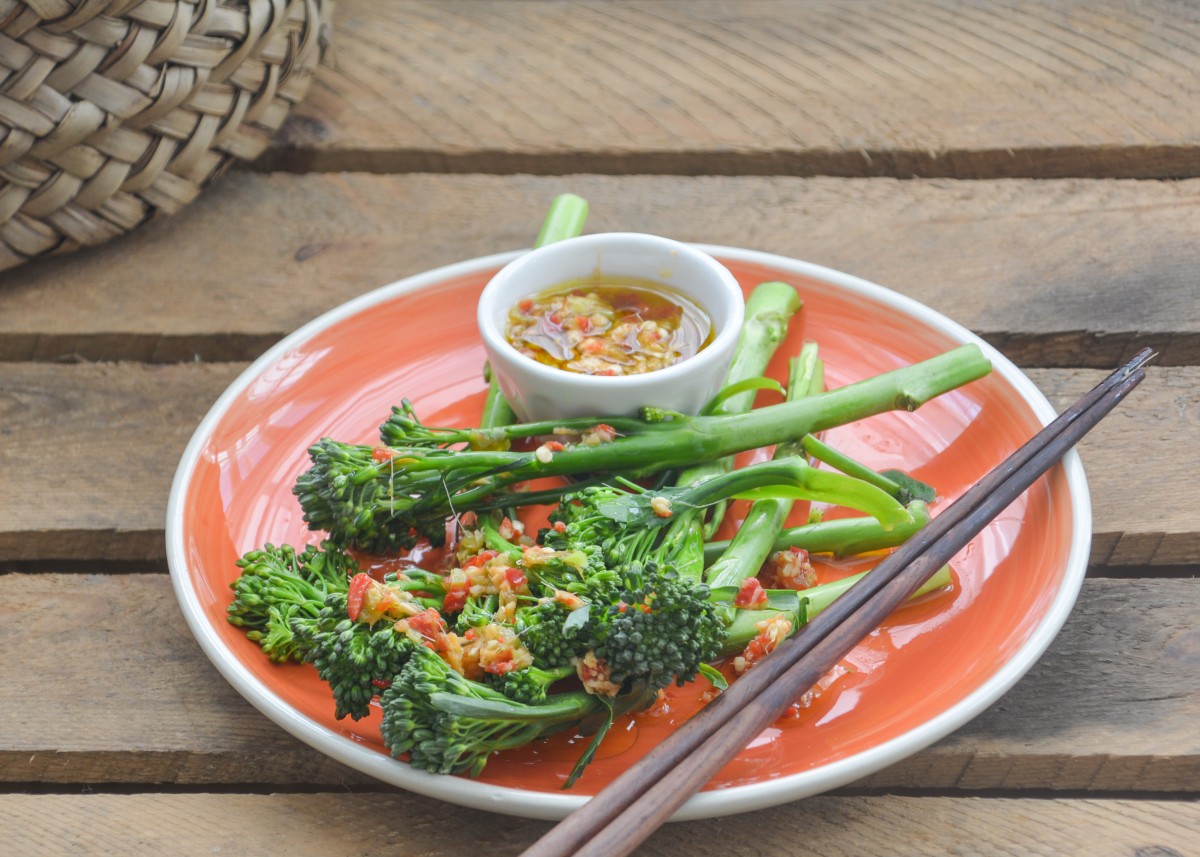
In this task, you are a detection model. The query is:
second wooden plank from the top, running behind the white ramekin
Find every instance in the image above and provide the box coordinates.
[0,174,1200,367]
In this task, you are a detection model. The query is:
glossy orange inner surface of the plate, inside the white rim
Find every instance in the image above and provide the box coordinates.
[177,260,1072,795]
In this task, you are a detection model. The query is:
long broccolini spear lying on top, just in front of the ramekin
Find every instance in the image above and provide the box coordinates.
[294,344,990,552]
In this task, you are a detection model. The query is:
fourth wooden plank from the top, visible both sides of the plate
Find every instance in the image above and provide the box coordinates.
[0,574,1200,793]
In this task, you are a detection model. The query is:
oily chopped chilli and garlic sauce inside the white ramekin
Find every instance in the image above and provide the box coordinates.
[505,275,713,376]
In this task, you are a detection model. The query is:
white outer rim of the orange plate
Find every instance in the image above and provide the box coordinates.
[166,244,1092,821]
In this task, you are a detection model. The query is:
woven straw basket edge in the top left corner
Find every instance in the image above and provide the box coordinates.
[0,0,334,270]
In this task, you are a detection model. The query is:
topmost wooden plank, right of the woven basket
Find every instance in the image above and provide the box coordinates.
[255,0,1200,179]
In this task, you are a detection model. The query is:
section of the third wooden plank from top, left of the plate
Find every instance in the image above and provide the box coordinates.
[0,364,244,561]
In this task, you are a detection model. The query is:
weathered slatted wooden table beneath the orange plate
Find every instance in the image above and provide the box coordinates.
[0,0,1200,857]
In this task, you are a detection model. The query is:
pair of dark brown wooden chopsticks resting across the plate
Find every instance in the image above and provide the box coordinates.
[522,348,1154,857]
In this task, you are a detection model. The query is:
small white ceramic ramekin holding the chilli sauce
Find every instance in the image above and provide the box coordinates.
[479,232,745,421]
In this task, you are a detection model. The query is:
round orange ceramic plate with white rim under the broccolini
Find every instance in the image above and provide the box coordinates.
[167,246,1091,820]
